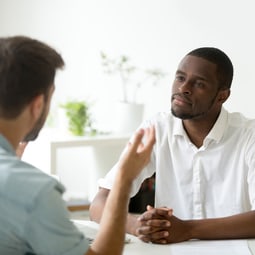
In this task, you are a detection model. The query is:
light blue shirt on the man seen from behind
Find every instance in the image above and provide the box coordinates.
[0,135,89,255]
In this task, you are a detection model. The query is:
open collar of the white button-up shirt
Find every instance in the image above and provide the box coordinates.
[173,107,228,142]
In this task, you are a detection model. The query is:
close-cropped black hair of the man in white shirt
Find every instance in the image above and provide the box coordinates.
[187,47,234,89]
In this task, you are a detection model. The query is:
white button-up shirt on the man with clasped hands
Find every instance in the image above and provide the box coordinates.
[99,109,255,219]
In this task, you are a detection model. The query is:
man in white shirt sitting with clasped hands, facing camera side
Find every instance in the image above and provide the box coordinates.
[90,47,255,243]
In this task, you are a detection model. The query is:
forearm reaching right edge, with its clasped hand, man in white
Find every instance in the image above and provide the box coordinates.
[138,211,255,244]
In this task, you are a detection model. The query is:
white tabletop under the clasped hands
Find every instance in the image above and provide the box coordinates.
[75,221,255,255]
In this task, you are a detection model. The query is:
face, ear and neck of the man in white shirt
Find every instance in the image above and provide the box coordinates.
[171,56,230,148]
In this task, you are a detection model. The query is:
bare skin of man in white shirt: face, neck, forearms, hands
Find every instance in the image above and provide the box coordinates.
[90,56,255,244]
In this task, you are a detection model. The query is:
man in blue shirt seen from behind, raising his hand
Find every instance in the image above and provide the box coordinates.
[0,36,155,255]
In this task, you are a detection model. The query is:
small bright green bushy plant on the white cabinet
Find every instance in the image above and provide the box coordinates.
[60,101,96,136]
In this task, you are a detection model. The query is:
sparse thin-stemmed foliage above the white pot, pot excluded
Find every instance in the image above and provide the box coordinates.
[100,52,167,103]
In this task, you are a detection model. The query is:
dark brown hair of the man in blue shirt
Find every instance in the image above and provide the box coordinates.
[0,36,64,119]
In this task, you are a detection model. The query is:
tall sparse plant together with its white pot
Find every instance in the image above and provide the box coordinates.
[100,52,167,133]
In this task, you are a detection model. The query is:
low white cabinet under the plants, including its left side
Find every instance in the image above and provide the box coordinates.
[23,130,129,204]
